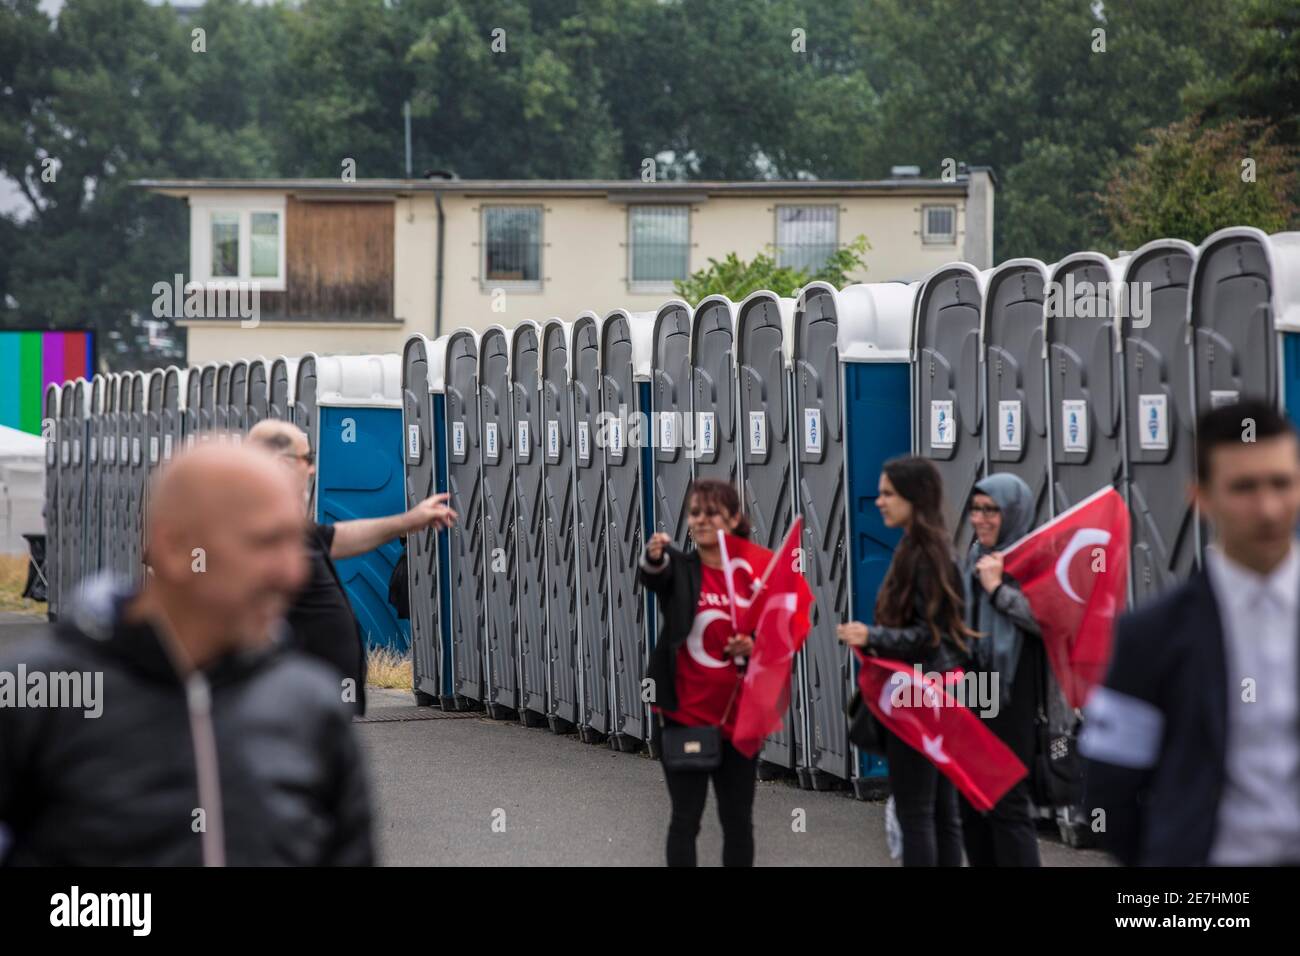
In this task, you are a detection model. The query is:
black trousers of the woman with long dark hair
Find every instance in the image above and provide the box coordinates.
[885,730,962,866]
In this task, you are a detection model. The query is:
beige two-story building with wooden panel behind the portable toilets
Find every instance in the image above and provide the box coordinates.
[137,168,995,363]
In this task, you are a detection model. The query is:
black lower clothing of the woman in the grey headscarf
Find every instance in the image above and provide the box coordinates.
[962,637,1045,866]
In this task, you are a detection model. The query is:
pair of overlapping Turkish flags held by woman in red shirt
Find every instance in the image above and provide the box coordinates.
[719,518,813,757]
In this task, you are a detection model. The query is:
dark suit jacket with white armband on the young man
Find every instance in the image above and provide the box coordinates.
[1079,570,1300,866]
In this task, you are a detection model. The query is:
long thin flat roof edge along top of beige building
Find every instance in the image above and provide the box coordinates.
[131,174,970,202]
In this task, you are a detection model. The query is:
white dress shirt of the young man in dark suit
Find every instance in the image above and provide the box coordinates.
[1205,541,1300,866]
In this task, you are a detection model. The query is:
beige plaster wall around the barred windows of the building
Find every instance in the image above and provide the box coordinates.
[189,193,966,364]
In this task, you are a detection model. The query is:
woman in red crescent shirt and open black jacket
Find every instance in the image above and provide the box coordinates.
[641,481,755,866]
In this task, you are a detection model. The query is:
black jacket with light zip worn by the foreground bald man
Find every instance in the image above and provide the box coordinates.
[0,589,373,866]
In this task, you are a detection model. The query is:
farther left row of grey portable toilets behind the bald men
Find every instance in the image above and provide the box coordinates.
[44,354,410,652]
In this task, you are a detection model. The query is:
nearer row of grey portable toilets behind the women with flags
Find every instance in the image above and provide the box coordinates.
[402,229,1300,790]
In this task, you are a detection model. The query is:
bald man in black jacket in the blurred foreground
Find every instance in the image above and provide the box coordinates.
[0,444,373,866]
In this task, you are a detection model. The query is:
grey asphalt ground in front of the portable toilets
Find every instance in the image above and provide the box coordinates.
[0,613,1106,866]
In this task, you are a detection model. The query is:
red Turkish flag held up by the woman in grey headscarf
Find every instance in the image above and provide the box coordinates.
[1002,488,1128,708]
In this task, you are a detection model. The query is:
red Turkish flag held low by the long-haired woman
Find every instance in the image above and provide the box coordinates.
[854,648,1028,812]
